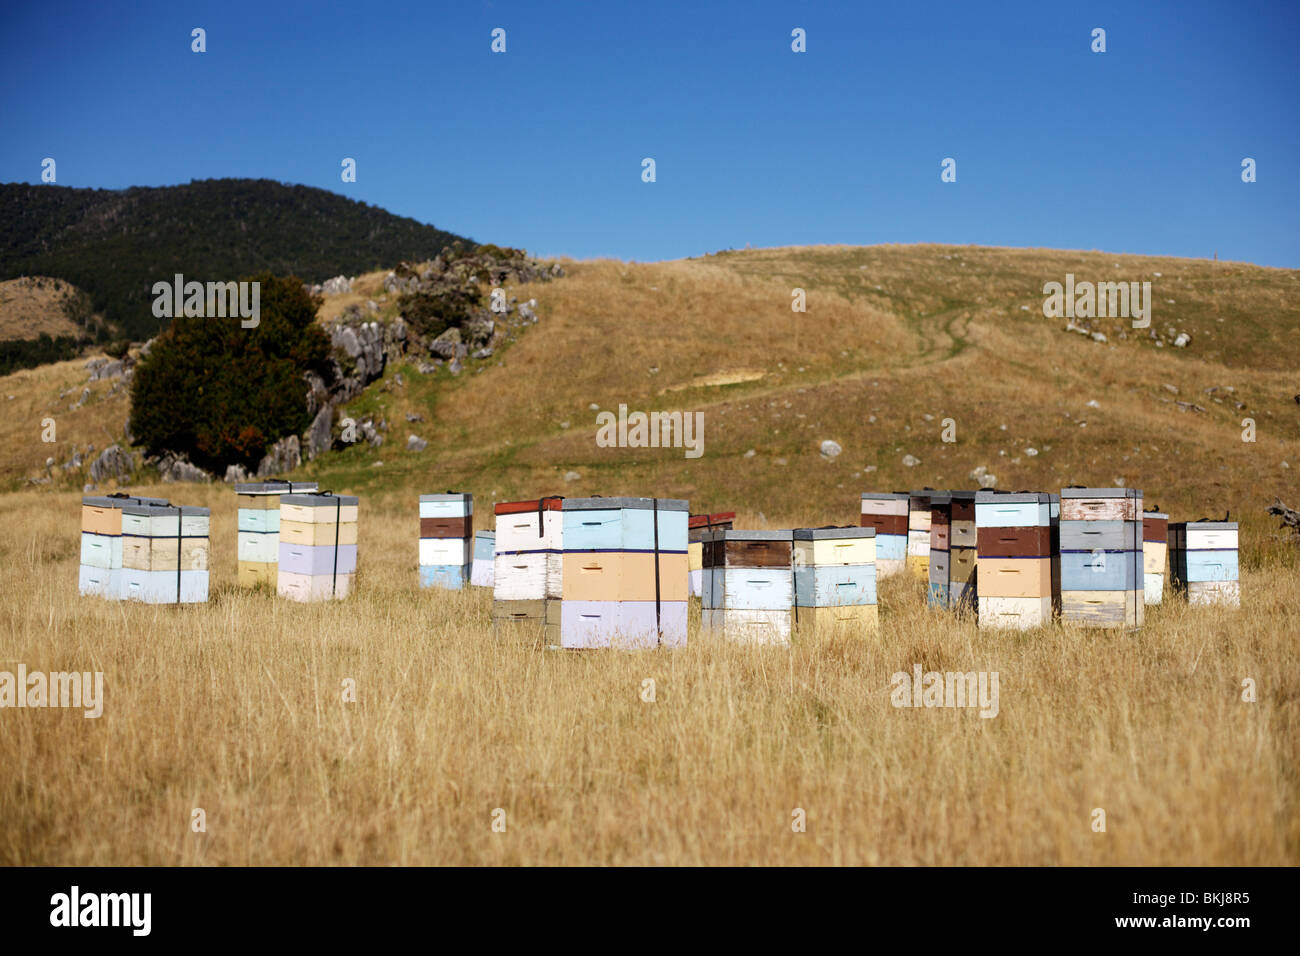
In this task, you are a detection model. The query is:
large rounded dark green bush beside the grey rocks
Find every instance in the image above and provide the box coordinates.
[131,273,332,473]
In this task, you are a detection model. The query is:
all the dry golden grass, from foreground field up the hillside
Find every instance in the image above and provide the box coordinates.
[0,246,1300,865]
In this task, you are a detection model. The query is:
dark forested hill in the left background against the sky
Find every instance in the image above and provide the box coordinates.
[0,179,475,341]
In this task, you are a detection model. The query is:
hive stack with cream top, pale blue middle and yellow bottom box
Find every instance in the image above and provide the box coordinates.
[794,527,879,633]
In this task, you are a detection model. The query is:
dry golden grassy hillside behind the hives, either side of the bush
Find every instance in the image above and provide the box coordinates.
[0,246,1300,548]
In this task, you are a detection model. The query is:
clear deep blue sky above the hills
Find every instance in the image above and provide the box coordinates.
[0,0,1300,267]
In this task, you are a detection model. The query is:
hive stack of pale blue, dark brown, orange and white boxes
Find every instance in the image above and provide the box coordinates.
[975,492,1054,630]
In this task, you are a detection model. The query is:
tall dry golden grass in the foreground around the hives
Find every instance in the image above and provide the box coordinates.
[0,488,1300,865]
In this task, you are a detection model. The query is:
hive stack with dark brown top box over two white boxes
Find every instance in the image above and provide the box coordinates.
[701,531,794,644]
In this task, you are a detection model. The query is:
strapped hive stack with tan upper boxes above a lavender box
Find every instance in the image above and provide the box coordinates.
[276,492,359,601]
